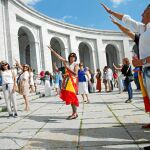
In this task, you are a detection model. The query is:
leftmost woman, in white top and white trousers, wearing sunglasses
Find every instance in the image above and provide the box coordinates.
[1,61,18,117]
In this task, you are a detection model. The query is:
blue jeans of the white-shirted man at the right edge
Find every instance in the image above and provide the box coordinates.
[143,67,150,98]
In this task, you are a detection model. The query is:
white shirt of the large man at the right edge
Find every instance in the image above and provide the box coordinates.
[122,15,150,67]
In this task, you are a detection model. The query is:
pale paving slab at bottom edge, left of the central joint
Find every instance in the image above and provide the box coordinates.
[23,129,79,149]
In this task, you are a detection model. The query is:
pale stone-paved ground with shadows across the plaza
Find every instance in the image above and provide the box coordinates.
[0,87,150,150]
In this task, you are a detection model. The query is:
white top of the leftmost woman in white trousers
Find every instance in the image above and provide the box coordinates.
[1,70,14,85]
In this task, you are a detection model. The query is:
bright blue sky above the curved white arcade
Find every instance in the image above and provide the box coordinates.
[22,0,150,30]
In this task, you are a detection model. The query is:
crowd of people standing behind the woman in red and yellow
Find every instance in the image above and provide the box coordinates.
[0,51,143,116]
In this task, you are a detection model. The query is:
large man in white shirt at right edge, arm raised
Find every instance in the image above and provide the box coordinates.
[101,4,150,128]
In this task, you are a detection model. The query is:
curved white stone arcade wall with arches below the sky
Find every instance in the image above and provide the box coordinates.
[0,0,132,72]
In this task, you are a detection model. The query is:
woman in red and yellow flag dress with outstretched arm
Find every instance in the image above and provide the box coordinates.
[48,47,79,120]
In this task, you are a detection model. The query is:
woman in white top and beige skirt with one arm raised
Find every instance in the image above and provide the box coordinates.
[16,61,30,111]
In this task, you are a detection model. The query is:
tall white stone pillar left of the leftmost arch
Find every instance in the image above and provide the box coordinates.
[2,0,19,65]
